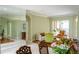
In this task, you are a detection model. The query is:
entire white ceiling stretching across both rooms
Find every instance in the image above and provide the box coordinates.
[0,5,79,16]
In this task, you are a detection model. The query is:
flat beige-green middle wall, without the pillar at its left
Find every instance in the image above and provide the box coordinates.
[31,15,50,38]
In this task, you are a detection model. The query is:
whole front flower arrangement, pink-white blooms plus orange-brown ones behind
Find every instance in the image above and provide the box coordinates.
[51,38,75,54]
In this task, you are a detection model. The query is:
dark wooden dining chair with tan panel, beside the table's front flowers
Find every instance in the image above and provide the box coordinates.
[39,41,49,54]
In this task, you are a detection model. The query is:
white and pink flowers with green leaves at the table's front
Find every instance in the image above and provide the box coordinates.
[51,42,69,54]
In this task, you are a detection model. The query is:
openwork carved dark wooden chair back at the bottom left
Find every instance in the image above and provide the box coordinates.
[16,46,32,54]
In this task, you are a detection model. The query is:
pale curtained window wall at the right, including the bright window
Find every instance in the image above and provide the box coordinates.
[51,16,79,38]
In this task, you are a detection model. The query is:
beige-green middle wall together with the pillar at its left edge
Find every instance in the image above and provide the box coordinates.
[28,14,50,40]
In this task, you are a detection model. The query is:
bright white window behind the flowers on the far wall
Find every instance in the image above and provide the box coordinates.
[52,20,69,35]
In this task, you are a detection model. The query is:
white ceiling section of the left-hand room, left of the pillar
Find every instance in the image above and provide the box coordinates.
[0,5,25,16]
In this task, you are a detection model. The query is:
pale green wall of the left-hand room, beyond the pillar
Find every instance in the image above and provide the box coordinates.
[0,17,26,39]
